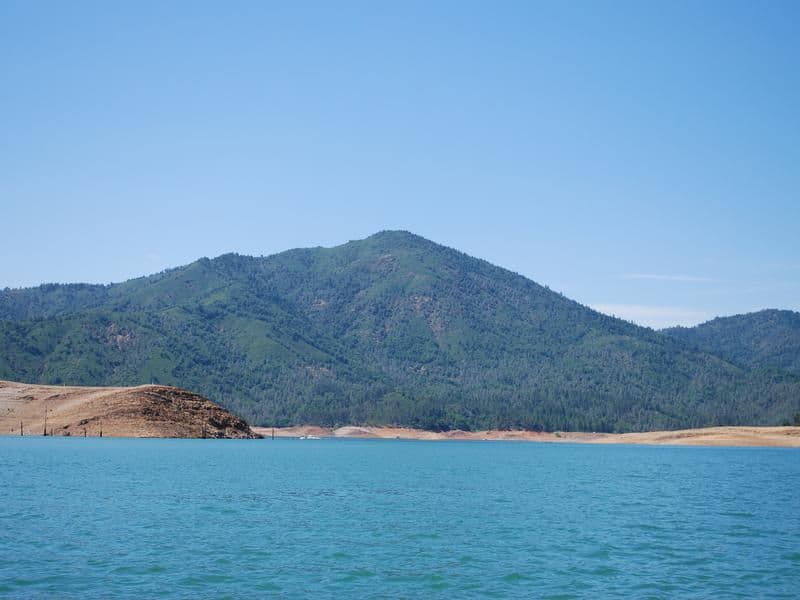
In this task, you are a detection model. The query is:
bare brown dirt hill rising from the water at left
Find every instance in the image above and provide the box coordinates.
[0,380,258,438]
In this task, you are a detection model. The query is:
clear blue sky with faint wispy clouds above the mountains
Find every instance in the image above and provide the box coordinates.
[0,0,800,328]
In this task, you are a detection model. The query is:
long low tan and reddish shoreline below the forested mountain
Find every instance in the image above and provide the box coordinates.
[252,425,800,448]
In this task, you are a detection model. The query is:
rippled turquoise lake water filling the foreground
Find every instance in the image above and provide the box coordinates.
[0,438,800,598]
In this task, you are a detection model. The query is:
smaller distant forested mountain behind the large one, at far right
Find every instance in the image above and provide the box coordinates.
[663,309,800,374]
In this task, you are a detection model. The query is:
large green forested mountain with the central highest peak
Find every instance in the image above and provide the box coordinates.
[0,231,800,431]
